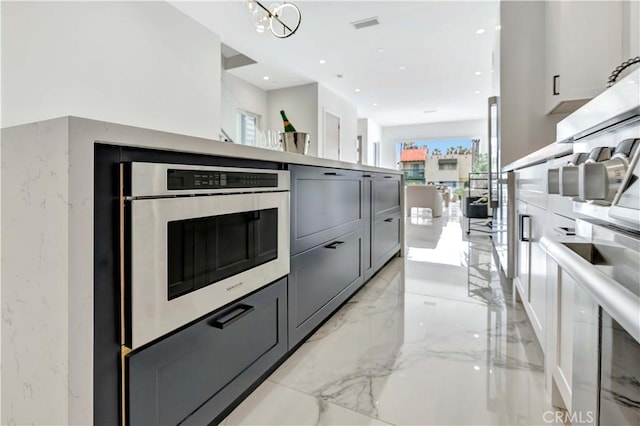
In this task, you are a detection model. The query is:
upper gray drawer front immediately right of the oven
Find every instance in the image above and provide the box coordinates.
[290,166,363,254]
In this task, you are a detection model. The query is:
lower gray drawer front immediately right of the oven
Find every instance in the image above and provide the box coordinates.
[289,230,363,347]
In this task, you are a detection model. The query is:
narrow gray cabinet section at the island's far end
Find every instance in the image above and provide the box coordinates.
[364,173,402,280]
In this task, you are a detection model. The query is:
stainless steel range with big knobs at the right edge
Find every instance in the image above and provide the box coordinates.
[542,70,640,425]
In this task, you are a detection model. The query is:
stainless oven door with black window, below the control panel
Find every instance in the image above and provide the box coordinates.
[128,192,289,349]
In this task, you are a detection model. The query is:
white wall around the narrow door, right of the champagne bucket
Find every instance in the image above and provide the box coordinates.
[318,85,358,163]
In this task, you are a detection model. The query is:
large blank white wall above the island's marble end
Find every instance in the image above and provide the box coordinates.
[1,1,220,139]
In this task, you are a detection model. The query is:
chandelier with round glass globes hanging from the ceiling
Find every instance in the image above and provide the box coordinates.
[244,0,302,38]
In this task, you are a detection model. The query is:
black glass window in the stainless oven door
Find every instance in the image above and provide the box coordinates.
[167,208,278,300]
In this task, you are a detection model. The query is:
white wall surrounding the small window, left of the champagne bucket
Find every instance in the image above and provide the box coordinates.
[221,71,268,142]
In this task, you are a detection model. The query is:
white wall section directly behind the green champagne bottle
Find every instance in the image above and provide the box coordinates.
[266,83,320,157]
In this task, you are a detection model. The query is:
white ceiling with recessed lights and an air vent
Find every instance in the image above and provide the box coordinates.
[171,0,499,126]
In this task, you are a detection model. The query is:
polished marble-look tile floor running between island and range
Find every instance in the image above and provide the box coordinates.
[223,204,552,426]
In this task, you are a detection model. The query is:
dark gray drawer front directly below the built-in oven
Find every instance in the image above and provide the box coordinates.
[127,278,288,425]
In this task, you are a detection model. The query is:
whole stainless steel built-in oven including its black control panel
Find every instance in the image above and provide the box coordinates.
[124,162,289,349]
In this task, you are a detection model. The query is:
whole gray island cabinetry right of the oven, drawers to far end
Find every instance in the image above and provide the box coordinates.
[288,165,402,348]
